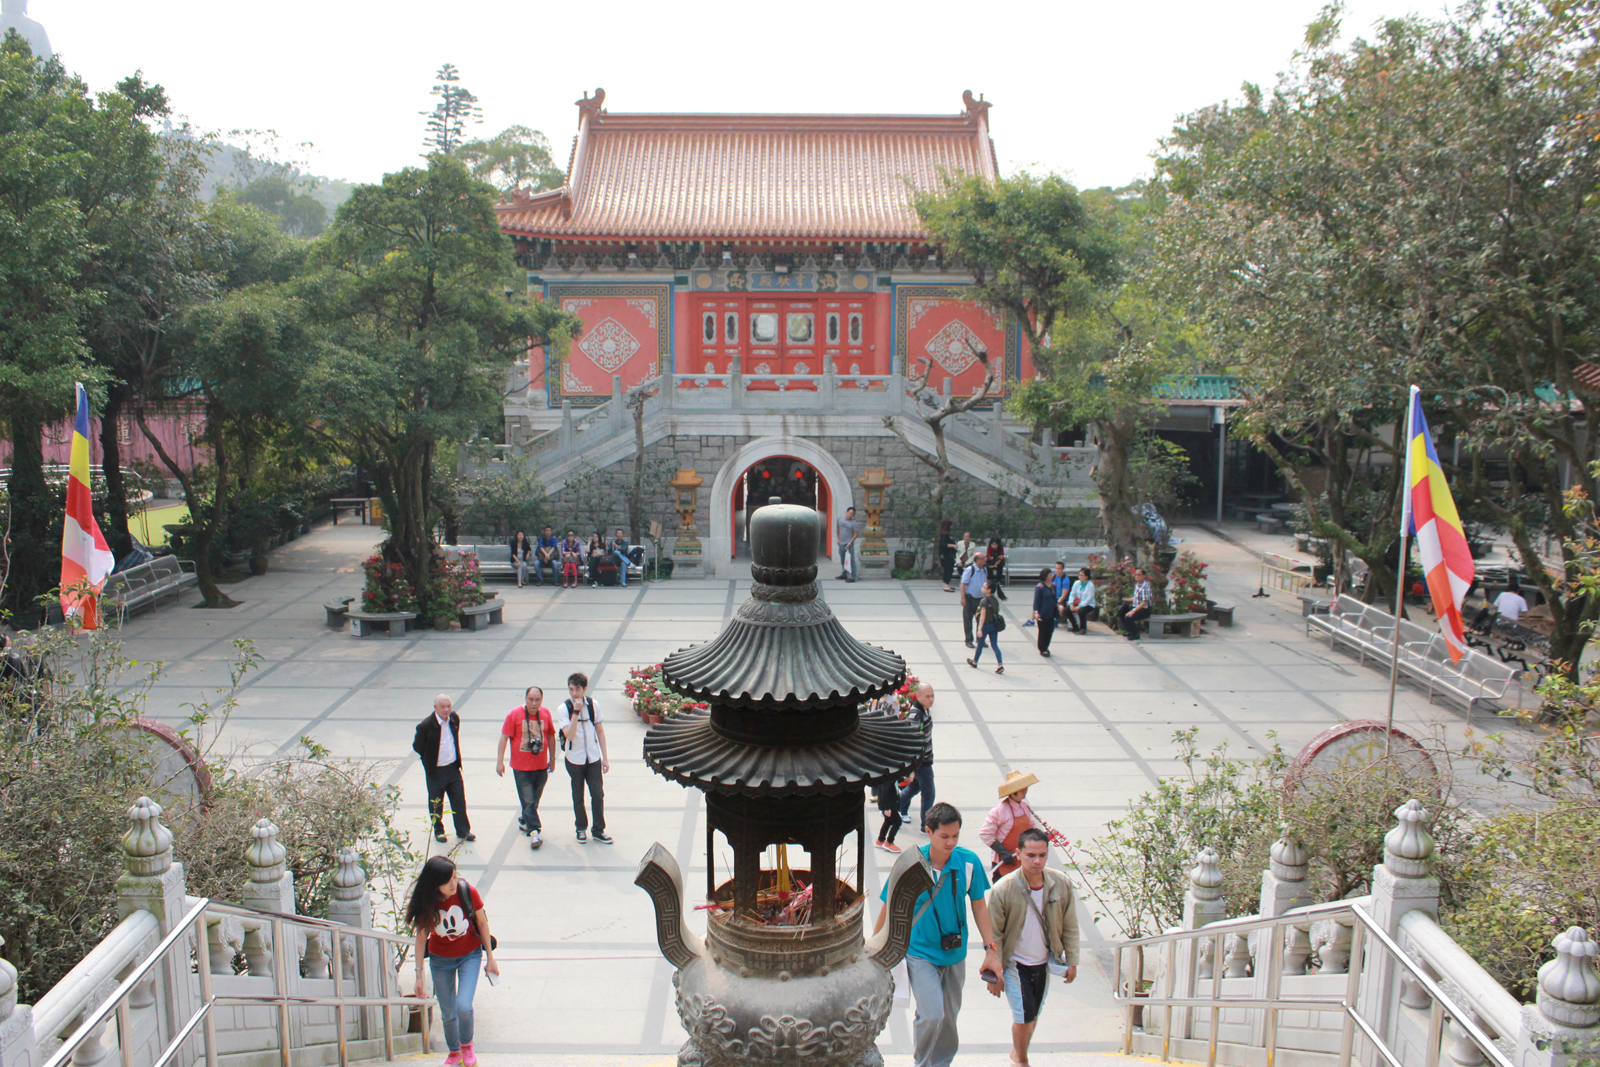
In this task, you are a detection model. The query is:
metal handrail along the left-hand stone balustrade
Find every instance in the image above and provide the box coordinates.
[42,897,437,1067]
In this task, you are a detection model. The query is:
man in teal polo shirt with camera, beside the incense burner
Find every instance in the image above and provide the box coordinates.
[874,803,1000,1067]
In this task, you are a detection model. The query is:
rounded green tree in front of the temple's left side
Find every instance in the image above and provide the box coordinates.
[304,154,581,597]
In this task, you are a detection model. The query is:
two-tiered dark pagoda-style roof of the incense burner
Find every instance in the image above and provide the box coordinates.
[645,504,922,795]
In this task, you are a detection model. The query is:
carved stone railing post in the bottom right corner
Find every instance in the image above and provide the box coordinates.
[1512,926,1600,1067]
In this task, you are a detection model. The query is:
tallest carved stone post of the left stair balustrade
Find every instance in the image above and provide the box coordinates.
[117,797,196,1067]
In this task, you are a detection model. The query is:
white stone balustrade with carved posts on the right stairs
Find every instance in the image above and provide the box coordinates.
[1131,800,1600,1067]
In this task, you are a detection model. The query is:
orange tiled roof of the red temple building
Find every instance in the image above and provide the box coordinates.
[496,90,997,240]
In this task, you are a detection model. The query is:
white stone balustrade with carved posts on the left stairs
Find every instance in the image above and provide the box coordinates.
[0,797,421,1067]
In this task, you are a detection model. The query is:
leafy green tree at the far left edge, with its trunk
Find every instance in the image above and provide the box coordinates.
[0,32,166,613]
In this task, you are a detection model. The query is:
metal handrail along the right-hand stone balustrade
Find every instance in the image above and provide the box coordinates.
[1112,901,1512,1067]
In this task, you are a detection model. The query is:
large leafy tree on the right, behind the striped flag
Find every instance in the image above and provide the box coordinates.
[1162,5,1600,672]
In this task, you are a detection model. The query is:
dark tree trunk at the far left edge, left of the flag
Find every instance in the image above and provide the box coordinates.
[3,403,61,625]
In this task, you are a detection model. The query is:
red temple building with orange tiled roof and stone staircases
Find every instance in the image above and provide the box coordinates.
[498,90,1098,573]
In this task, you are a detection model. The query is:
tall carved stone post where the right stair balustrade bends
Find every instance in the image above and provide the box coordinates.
[1350,800,1438,1048]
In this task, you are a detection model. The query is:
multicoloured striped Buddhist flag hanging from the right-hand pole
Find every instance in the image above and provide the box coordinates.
[1400,386,1474,662]
